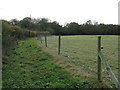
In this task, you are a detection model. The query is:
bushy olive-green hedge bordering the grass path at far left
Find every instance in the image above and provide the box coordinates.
[2,21,37,54]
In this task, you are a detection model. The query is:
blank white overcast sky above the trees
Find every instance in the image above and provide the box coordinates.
[0,0,120,25]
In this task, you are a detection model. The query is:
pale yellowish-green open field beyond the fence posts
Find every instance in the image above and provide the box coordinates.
[43,35,118,86]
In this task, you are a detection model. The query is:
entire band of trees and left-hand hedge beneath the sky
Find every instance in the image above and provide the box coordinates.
[2,17,120,54]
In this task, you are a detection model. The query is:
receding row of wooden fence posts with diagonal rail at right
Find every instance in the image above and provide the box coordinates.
[36,34,120,89]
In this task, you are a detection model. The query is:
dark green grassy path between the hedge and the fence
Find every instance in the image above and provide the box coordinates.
[2,38,90,88]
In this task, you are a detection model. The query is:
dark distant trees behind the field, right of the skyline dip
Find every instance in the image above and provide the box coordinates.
[62,22,118,35]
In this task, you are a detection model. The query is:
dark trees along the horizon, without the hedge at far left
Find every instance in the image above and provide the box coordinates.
[9,17,120,35]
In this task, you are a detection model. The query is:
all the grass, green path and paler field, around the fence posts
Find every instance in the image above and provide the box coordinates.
[2,35,118,88]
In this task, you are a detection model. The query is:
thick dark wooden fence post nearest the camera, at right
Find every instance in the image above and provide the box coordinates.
[98,36,102,81]
